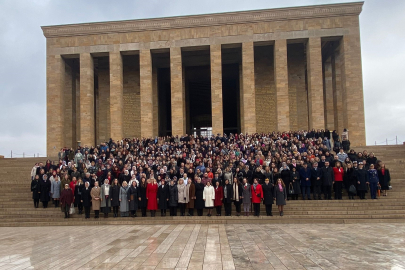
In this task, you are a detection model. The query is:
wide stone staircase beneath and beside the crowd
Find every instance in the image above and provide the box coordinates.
[0,146,405,227]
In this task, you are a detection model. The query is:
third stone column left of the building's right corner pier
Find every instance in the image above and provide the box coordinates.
[240,42,256,134]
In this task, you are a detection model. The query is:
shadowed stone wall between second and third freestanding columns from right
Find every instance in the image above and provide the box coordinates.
[255,46,277,133]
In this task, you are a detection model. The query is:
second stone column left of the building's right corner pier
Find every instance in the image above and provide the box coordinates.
[274,39,290,131]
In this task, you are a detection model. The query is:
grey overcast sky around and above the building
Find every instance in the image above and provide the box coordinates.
[0,0,405,157]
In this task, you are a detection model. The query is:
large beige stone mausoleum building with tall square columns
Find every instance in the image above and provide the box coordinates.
[42,2,365,156]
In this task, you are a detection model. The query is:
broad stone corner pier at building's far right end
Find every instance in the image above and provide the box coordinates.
[339,24,366,146]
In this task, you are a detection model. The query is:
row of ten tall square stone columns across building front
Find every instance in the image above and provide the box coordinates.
[47,36,364,155]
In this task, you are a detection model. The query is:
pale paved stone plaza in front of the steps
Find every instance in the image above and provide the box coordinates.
[0,224,405,270]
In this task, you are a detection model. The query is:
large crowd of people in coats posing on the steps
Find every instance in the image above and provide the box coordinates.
[31,130,391,219]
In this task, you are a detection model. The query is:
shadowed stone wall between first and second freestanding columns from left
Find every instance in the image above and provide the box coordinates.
[96,68,111,144]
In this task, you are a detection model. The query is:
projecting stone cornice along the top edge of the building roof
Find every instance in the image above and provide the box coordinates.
[41,2,364,38]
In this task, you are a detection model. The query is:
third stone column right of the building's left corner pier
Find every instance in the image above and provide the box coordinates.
[139,49,153,138]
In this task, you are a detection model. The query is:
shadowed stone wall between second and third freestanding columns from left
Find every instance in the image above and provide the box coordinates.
[123,56,141,138]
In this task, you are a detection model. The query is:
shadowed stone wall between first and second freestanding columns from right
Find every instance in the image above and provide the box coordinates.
[287,44,308,130]
